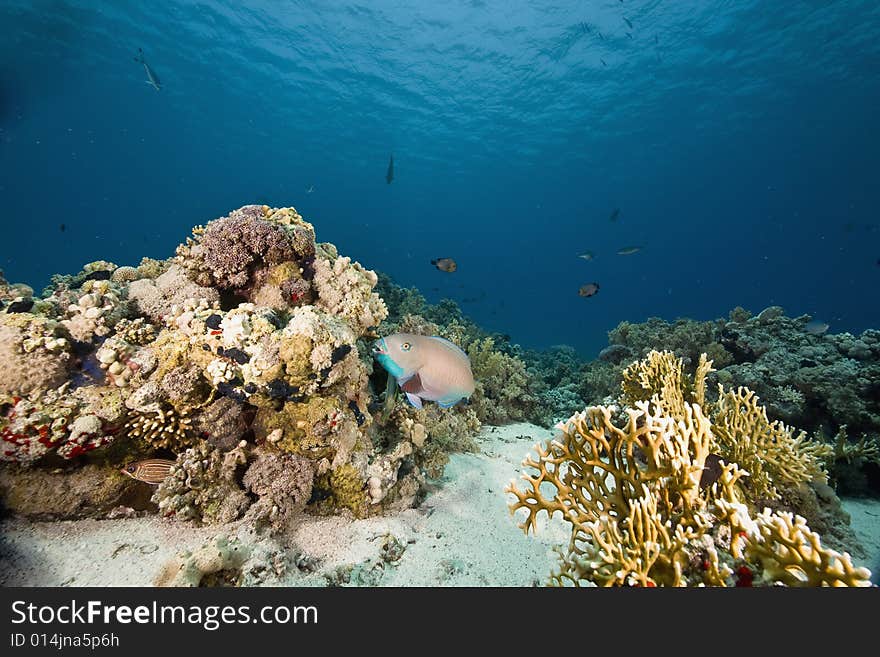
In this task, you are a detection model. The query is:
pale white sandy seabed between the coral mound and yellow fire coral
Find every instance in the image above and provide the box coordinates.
[0,424,880,586]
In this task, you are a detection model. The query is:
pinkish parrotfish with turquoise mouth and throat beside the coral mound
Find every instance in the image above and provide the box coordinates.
[373,333,474,408]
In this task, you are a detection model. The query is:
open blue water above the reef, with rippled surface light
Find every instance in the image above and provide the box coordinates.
[0,0,880,355]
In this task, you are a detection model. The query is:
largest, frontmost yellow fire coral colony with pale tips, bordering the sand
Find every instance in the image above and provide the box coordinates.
[507,402,735,586]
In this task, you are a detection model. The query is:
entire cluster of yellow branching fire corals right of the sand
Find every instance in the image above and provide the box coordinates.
[507,352,870,586]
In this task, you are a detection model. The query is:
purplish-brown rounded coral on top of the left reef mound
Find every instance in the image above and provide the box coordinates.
[199,205,295,289]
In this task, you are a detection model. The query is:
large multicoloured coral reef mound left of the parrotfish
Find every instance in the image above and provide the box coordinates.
[0,206,446,530]
